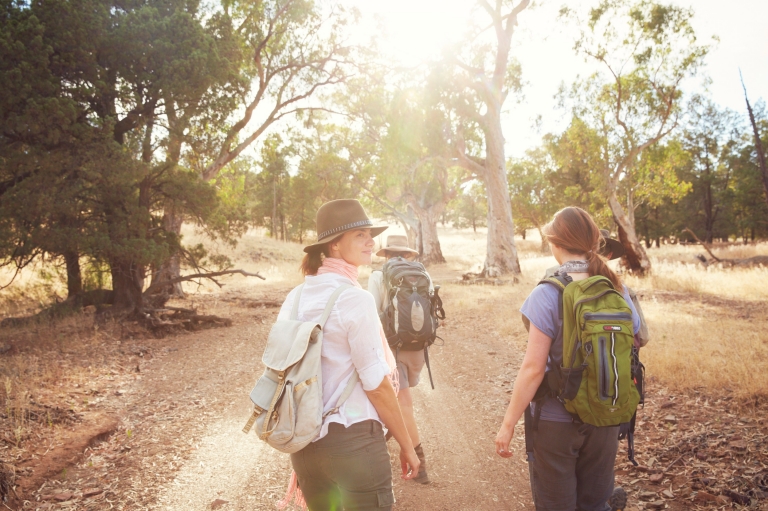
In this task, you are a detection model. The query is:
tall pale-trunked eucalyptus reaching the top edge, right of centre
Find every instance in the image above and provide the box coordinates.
[443,0,530,277]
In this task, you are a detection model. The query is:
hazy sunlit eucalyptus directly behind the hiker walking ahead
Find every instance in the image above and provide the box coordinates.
[347,76,474,264]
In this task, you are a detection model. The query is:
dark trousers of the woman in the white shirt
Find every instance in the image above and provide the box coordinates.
[291,420,395,511]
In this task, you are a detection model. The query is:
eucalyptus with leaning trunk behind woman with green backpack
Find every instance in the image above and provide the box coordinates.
[561,0,708,274]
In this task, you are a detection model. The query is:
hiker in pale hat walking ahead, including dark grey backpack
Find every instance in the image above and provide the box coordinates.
[368,235,445,484]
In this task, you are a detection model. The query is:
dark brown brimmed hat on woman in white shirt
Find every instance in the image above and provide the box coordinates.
[304,199,388,253]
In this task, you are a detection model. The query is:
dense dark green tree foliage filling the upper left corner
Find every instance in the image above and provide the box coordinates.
[0,0,237,302]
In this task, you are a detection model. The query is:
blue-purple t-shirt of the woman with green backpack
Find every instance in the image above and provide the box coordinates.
[520,284,640,422]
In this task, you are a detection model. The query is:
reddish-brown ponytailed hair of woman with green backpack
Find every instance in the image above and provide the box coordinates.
[542,207,622,291]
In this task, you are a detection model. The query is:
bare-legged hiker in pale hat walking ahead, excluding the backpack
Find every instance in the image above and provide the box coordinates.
[368,235,434,484]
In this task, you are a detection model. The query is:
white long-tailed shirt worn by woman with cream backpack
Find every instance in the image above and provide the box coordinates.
[278,273,390,441]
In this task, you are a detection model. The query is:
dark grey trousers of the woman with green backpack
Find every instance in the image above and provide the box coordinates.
[528,420,619,511]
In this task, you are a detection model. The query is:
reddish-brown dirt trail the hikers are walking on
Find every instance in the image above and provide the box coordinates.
[19,285,531,511]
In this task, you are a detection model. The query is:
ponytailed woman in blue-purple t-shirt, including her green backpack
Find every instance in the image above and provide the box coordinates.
[495,207,640,511]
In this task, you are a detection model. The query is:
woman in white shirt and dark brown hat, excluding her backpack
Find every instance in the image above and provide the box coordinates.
[278,199,419,511]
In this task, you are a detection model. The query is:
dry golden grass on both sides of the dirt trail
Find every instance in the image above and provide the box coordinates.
[0,226,768,409]
